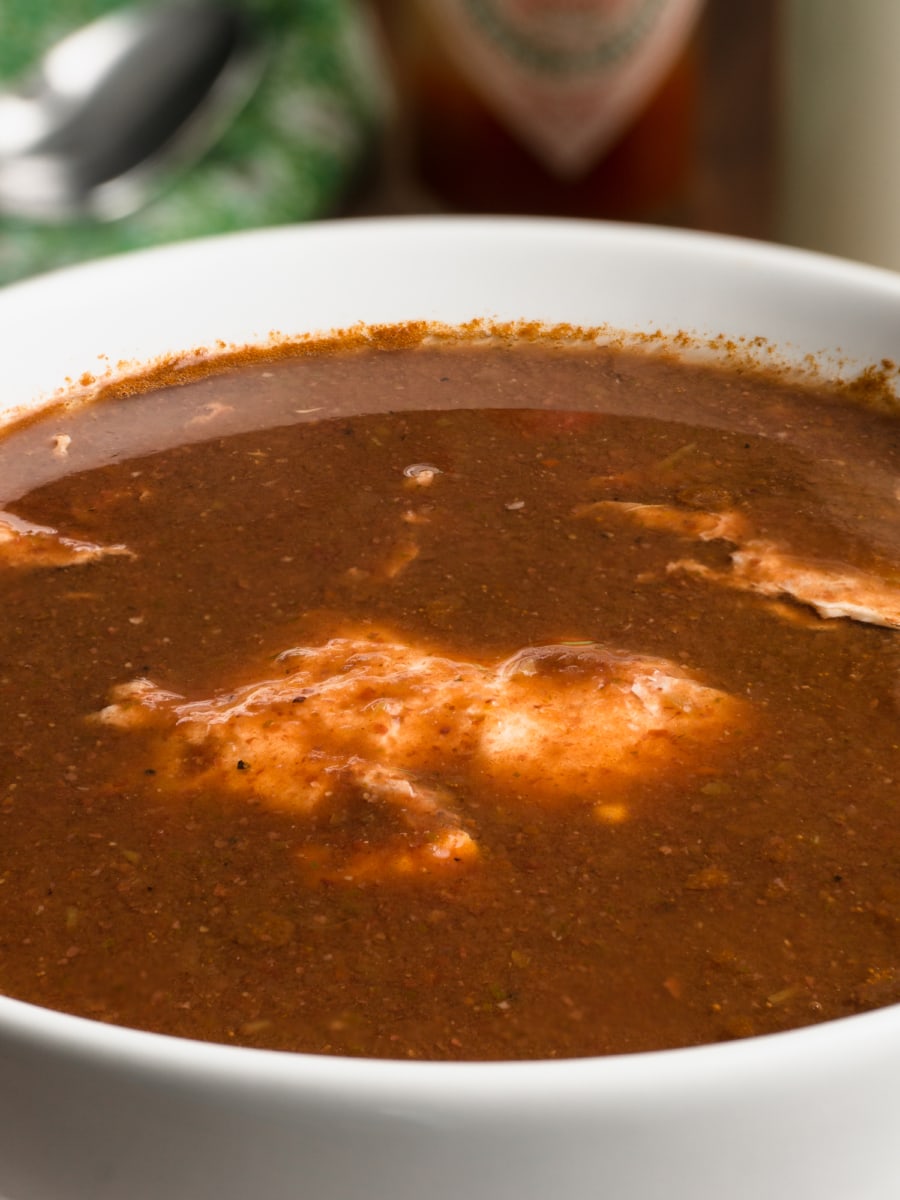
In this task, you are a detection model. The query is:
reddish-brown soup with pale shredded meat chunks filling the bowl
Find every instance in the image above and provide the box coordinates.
[0,341,900,1058]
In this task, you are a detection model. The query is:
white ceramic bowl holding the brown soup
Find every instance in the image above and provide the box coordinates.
[0,218,900,1200]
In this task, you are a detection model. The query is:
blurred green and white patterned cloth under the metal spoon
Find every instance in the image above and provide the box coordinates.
[0,0,385,284]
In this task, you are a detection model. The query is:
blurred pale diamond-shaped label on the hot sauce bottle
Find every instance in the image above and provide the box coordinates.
[425,0,702,178]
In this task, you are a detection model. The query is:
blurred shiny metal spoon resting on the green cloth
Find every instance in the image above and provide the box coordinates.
[0,0,263,222]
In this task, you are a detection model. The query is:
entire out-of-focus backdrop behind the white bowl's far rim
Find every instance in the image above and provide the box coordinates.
[0,0,900,283]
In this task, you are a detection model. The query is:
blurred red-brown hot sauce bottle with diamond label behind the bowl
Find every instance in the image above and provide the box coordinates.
[382,0,701,222]
